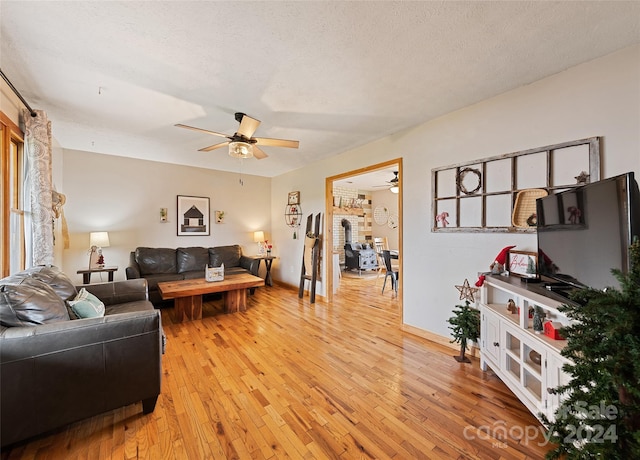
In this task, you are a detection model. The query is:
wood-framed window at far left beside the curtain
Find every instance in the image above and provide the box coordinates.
[0,112,25,277]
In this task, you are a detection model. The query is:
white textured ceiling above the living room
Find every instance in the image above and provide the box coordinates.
[0,0,640,176]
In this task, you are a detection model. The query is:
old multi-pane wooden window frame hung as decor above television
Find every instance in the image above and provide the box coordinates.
[431,137,601,233]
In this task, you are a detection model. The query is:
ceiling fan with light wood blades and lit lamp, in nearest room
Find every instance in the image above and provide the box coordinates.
[176,112,300,160]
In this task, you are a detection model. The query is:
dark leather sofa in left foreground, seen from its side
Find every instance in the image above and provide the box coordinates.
[0,267,164,447]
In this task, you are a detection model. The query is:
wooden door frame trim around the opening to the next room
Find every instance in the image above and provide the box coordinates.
[325,157,404,312]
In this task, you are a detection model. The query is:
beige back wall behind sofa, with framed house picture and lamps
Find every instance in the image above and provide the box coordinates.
[61,150,270,282]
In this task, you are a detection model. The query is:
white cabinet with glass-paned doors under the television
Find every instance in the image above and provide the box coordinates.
[480,275,570,420]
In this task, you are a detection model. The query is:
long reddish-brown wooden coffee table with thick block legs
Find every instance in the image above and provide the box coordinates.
[158,273,264,323]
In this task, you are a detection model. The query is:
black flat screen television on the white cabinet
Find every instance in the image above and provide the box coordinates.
[536,172,640,294]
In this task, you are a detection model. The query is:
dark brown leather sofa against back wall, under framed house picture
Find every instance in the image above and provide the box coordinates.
[125,244,260,304]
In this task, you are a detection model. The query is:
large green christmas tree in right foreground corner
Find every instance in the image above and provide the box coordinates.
[546,238,640,460]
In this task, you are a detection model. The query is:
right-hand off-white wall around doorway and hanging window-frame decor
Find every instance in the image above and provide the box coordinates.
[272,46,640,336]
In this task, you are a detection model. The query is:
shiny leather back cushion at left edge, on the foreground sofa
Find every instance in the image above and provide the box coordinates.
[0,276,69,327]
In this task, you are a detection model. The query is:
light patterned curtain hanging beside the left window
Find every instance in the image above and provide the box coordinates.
[22,109,53,266]
